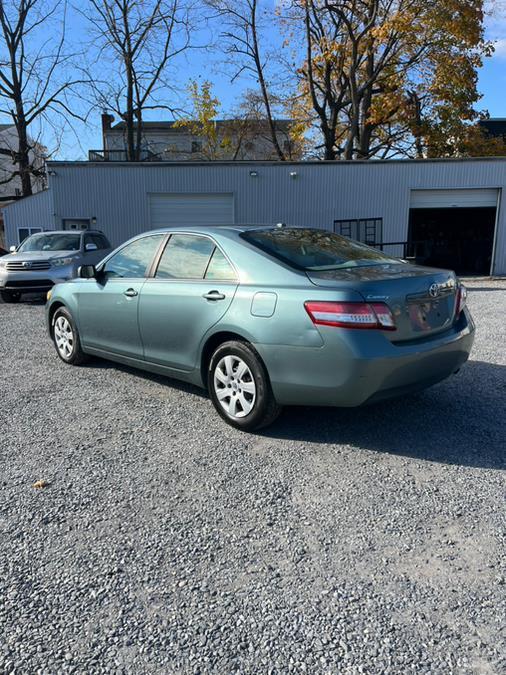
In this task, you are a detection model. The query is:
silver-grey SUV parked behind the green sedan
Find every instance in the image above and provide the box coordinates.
[0,230,111,302]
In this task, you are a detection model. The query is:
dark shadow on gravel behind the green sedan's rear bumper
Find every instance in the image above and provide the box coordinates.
[262,361,506,469]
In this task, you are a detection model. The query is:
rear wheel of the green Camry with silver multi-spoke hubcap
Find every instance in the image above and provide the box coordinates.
[207,340,281,431]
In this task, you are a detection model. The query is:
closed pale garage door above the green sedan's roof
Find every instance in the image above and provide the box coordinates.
[149,192,234,229]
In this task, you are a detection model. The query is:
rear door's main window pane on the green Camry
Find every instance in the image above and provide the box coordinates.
[155,234,215,279]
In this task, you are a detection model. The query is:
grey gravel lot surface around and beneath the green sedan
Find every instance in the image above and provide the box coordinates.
[0,280,506,675]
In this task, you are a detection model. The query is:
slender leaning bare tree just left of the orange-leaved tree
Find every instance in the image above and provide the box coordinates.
[206,0,286,160]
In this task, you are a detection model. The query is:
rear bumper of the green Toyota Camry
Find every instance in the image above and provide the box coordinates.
[255,310,474,407]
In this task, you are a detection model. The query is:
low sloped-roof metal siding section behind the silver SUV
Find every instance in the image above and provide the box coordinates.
[3,190,54,246]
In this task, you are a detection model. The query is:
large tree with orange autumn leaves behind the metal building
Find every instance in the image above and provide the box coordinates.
[284,0,497,159]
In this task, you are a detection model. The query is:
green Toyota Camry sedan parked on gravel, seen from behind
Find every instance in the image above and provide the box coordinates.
[47,225,474,430]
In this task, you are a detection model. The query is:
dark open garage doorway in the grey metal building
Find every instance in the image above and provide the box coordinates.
[408,207,496,276]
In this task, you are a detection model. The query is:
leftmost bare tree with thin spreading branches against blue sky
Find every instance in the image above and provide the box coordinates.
[0,0,83,196]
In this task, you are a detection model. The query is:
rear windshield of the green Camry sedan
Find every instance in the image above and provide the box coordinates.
[241,228,400,272]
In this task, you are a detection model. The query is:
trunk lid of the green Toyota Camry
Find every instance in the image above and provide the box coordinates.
[307,263,458,343]
